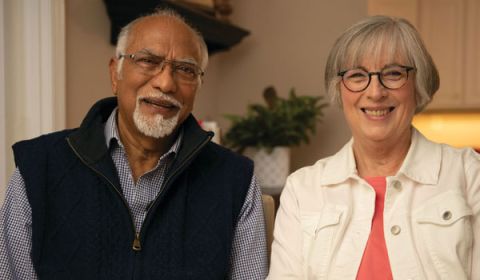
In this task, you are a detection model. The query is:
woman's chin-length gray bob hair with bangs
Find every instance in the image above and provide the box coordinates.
[325,16,440,113]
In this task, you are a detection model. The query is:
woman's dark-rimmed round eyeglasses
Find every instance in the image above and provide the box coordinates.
[338,65,415,92]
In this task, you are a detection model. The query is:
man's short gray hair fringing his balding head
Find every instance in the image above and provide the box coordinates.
[115,9,208,77]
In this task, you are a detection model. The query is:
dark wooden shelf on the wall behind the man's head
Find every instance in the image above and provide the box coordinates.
[104,0,250,54]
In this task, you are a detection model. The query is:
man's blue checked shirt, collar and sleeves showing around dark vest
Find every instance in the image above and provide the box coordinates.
[0,110,267,280]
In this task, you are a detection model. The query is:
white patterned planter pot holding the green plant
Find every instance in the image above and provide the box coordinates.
[244,147,290,189]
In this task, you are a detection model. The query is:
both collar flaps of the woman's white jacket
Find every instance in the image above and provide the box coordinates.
[323,127,442,185]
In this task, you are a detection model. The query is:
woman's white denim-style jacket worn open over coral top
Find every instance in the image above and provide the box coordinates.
[268,129,480,280]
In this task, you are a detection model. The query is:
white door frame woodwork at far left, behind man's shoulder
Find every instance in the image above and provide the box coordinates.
[0,0,66,199]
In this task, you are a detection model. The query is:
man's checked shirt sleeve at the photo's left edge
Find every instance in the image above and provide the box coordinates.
[0,168,37,280]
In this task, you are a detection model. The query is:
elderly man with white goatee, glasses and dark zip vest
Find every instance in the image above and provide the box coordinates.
[0,10,267,280]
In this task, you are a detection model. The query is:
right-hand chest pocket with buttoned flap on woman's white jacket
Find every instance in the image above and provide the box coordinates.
[413,191,473,279]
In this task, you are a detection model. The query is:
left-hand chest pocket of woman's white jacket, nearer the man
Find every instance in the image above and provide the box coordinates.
[300,204,344,279]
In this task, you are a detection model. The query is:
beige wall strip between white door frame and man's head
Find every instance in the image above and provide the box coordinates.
[66,0,114,128]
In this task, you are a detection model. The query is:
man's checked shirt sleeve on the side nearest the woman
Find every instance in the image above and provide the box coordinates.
[229,176,268,280]
